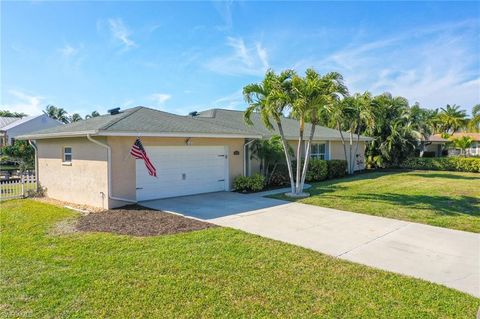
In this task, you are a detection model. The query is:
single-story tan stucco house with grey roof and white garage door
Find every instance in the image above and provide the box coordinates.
[18,107,370,208]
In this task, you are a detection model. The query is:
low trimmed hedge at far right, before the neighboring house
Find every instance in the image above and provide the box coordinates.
[400,156,480,173]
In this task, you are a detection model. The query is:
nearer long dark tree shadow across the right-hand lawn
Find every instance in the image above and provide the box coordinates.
[327,193,480,217]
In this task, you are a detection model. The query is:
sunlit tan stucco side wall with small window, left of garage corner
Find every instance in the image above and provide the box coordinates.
[37,137,108,208]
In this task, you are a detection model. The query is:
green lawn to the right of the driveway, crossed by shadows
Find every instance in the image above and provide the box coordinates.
[272,171,480,233]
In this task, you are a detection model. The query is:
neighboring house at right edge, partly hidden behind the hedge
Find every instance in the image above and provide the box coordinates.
[425,132,480,157]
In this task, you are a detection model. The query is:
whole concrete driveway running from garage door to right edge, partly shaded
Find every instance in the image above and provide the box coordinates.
[140,192,480,297]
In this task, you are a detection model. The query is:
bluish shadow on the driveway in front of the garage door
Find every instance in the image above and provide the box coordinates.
[138,192,289,220]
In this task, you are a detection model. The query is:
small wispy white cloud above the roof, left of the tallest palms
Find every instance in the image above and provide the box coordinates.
[206,37,269,75]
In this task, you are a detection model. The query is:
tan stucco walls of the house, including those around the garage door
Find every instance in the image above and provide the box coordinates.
[38,137,244,208]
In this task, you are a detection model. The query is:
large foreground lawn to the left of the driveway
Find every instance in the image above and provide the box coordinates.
[0,200,480,318]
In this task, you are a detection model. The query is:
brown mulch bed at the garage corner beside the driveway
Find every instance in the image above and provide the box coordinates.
[76,205,217,236]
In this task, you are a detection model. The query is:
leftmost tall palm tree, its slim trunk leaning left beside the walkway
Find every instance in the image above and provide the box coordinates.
[243,70,295,194]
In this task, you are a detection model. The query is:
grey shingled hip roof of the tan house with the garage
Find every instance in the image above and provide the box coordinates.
[19,106,370,140]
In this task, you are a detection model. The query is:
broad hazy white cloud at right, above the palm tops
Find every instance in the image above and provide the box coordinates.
[296,21,480,109]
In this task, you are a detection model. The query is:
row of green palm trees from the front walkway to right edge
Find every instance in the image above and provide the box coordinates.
[243,69,480,195]
